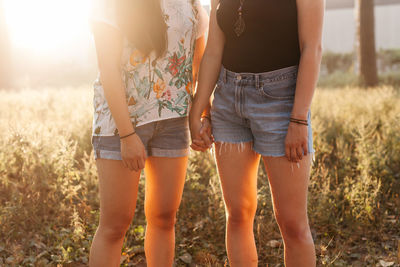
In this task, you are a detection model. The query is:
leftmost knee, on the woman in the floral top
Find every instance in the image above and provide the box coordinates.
[98,214,133,242]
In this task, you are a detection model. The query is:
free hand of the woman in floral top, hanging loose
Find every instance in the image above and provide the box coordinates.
[121,134,146,172]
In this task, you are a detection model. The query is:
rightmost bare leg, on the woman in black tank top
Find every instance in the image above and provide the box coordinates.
[263,155,316,267]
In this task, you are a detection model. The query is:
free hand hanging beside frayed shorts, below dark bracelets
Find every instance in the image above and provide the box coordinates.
[285,122,308,162]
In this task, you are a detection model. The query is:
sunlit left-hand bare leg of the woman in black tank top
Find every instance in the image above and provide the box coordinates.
[215,143,260,267]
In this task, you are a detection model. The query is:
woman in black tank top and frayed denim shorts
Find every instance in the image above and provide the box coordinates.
[190,0,324,267]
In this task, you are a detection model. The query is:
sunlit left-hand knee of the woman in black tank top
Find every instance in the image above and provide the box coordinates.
[227,202,257,226]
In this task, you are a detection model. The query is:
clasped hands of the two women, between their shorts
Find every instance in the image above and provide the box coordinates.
[189,117,214,152]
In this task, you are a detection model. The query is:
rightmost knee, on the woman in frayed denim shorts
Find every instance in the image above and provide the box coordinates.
[277,217,313,243]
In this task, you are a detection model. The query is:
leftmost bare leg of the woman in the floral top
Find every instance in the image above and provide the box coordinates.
[89,159,140,267]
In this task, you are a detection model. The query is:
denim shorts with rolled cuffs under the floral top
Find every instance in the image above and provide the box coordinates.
[92,117,190,160]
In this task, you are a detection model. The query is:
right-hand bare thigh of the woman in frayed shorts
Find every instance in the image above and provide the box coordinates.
[263,154,311,220]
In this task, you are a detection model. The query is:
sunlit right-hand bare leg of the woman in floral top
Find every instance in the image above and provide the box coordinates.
[145,157,187,267]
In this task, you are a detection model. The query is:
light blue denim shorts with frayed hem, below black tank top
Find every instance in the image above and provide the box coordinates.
[211,66,314,157]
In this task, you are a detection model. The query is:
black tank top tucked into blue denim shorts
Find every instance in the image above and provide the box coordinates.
[217,0,300,73]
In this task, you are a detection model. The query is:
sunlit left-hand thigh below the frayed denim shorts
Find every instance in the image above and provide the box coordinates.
[215,142,260,212]
